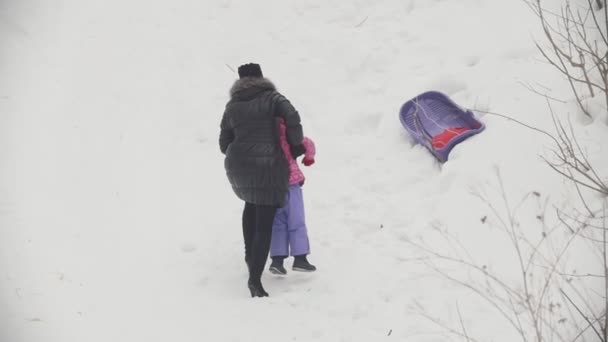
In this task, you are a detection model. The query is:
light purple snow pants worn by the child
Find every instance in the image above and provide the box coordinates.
[270,184,310,257]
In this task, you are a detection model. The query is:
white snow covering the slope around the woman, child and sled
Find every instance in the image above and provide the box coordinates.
[0,0,608,342]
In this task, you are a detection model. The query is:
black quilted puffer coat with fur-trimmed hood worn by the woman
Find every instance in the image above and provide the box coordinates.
[219,77,303,206]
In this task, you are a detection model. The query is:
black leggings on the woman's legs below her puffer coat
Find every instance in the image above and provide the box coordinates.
[243,202,277,283]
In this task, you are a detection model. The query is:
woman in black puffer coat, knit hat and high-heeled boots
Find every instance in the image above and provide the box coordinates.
[219,63,304,297]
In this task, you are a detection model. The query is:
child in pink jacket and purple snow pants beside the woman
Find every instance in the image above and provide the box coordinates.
[270,119,317,275]
